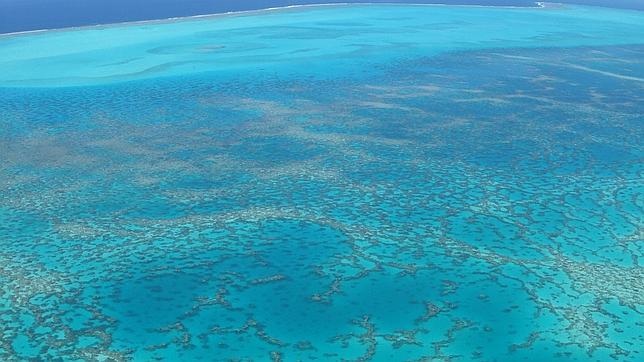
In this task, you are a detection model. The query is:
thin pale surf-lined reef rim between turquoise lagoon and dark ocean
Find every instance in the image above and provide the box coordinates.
[0,1,548,39]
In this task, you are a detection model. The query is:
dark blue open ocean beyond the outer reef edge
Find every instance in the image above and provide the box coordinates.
[0,0,644,33]
